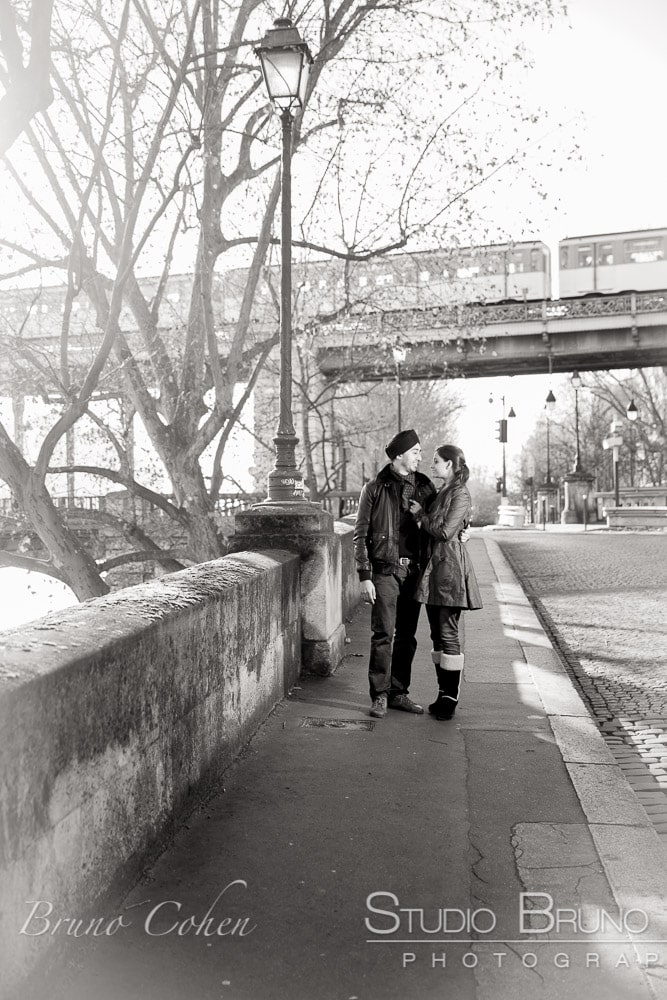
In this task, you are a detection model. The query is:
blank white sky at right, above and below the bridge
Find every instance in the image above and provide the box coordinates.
[457,0,667,474]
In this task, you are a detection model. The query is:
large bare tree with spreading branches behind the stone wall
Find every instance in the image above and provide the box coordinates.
[0,0,568,598]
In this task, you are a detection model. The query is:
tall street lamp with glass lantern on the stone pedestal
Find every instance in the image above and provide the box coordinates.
[255,17,313,503]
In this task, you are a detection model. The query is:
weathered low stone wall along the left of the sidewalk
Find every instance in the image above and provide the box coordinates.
[0,550,301,996]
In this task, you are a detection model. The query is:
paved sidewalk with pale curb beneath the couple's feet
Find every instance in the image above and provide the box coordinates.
[27,535,667,1000]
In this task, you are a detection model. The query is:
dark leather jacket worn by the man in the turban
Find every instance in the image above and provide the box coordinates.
[354,464,437,580]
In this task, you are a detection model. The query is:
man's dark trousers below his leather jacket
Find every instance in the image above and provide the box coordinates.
[368,567,421,700]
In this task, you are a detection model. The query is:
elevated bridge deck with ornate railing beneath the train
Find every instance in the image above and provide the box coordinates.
[317,291,667,382]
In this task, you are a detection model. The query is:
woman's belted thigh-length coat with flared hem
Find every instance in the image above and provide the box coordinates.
[415,483,482,611]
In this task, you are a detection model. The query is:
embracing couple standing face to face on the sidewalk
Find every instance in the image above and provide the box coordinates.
[354,430,482,719]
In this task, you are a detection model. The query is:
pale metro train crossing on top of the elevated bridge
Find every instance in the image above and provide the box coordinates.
[220,228,667,319]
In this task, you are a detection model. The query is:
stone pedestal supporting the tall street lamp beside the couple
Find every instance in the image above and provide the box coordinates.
[229,501,345,676]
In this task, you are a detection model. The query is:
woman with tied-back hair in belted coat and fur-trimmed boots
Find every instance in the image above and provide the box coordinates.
[410,444,482,719]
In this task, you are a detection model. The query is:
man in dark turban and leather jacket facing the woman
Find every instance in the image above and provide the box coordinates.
[354,430,436,719]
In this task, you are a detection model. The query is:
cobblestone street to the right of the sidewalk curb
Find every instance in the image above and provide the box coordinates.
[494,531,667,843]
